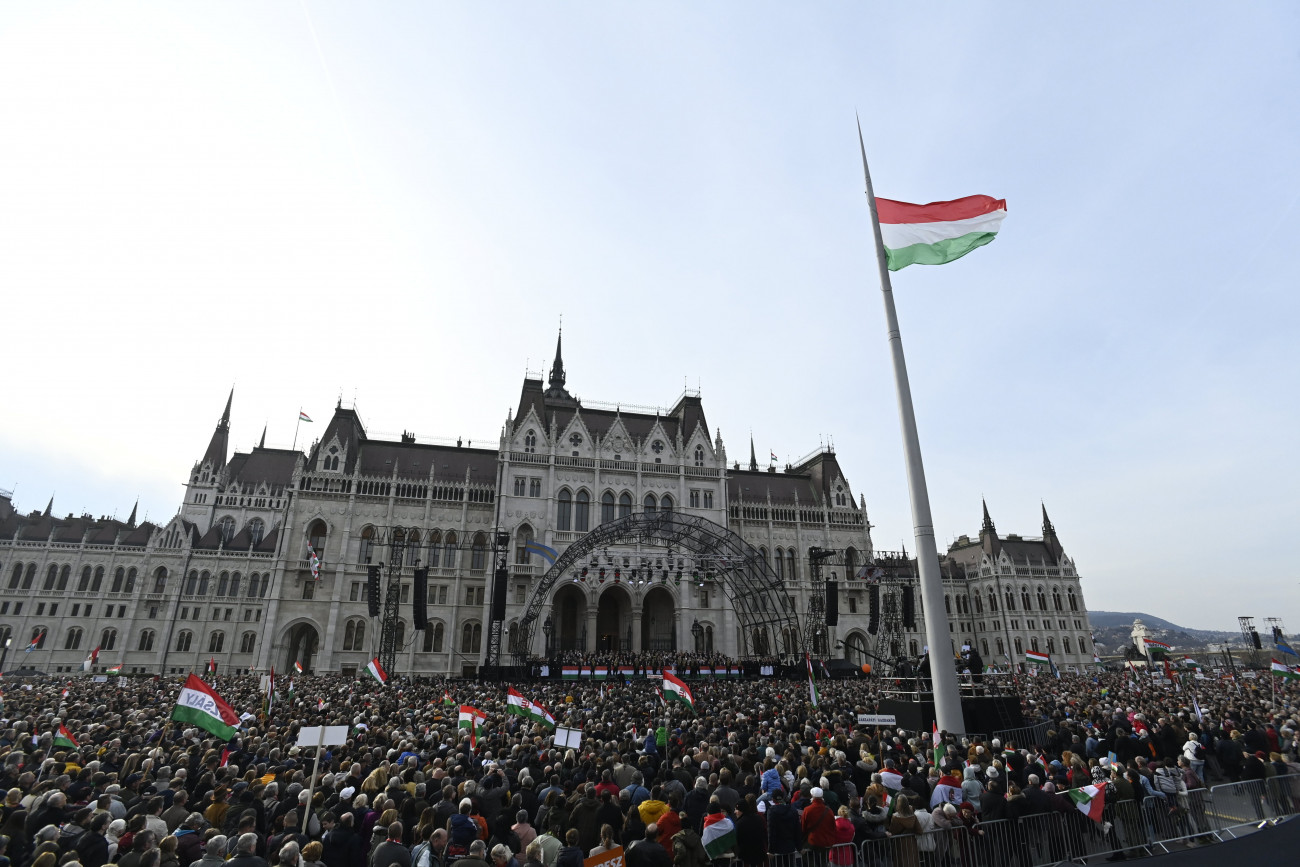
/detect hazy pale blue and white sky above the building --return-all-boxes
[0,1,1300,630]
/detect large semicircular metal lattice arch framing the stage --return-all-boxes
[515,511,803,663]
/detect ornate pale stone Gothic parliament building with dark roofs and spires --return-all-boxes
[0,343,1093,676]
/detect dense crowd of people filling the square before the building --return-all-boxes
[0,660,1300,867]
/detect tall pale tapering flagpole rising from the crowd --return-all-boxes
[858,120,966,732]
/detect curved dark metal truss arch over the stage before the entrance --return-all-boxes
[515,511,803,664]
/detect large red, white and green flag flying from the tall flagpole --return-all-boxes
[876,196,1006,270]
